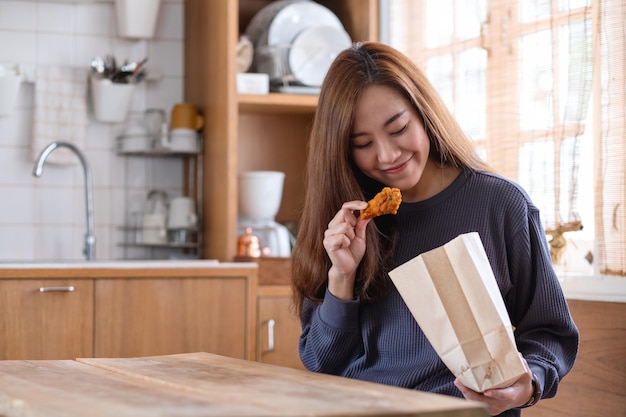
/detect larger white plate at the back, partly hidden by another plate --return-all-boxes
[267,1,343,45]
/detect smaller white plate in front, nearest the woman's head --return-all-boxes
[289,26,352,87]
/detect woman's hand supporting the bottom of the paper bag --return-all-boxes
[454,354,534,416]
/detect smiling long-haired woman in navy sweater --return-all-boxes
[292,43,578,417]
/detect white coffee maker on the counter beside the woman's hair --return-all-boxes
[238,171,291,257]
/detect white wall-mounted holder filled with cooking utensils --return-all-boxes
[91,77,135,123]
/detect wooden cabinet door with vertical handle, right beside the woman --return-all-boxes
[257,286,304,369]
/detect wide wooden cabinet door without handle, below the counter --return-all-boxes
[95,277,247,359]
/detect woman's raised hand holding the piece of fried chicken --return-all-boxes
[324,201,369,300]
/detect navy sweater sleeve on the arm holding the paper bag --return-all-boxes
[505,205,579,398]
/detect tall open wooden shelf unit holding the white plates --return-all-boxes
[184,0,379,260]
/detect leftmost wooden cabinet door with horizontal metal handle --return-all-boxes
[0,279,93,360]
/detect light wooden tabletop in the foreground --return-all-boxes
[0,353,487,417]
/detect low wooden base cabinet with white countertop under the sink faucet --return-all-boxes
[0,261,257,360]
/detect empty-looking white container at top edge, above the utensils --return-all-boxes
[115,0,161,39]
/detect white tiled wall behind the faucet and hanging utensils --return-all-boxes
[0,0,184,262]
